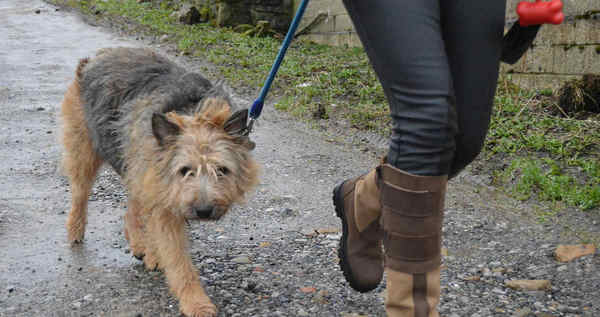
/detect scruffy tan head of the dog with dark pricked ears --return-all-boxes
[152,96,259,220]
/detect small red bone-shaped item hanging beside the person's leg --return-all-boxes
[517,0,565,26]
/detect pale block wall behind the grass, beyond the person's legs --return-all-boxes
[296,0,600,88]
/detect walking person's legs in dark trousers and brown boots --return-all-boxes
[334,0,505,316]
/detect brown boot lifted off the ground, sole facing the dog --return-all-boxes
[333,169,383,292]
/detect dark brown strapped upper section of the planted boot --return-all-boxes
[380,164,447,273]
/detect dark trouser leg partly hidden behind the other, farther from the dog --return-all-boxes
[441,0,506,178]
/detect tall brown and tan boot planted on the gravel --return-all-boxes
[380,164,448,317]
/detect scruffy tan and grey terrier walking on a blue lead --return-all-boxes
[62,48,258,317]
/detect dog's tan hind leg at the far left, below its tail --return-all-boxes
[61,80,102,243]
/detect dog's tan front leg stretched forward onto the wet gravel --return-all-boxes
[147,212,217,317]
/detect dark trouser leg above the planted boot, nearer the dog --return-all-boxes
[344,0,457,176]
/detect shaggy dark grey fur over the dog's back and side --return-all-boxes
[79,48,236,175]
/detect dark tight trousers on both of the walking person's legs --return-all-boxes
[344,0,506,177]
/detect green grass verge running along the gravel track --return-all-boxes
[56,0,600,210]
